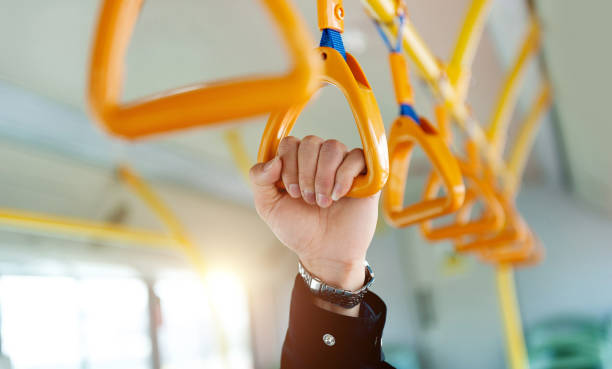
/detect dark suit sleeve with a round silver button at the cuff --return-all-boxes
[281,275,392,369]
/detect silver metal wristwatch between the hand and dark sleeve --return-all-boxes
[298,261,374,309]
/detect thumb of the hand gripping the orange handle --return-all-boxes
[249,157,283,219]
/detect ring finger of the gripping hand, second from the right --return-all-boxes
[315,140,346,208]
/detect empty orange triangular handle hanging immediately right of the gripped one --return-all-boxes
[383,116,465,227]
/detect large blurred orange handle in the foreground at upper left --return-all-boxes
[88,0,321,139]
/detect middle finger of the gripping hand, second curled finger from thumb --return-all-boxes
[298,136,323,205]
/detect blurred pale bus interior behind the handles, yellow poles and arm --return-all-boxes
[0,0,612,369]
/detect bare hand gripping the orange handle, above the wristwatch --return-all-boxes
[250,136,379,314]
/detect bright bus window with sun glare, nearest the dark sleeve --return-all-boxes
[156,272,253,369]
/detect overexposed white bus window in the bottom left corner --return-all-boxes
[0,276,151,369]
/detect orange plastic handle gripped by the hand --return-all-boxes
[257,47,389,197]
